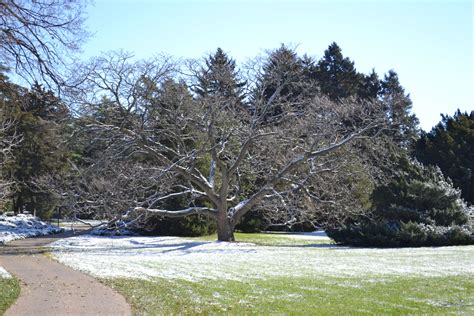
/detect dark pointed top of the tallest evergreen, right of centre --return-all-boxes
[315,42,363,100]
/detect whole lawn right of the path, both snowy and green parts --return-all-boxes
[52,234,474,315]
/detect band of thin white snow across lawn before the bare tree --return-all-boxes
[51,235,474,281]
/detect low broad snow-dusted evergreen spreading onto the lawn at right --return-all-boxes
[328,163,474,247]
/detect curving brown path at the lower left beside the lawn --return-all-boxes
[0,232,131,316]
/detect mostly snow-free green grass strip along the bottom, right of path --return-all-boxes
[104,275,474,315]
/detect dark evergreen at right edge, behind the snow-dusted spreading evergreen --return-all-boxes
[415,110,474,204]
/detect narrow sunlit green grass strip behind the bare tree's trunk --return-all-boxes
[189,233,334,246]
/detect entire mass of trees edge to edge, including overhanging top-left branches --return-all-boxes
[0,0,473,246]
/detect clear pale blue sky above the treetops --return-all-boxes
[83,0,474,130]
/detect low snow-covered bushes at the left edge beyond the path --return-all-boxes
[0,214,63,245]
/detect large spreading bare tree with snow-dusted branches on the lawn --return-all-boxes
[67,54,385,241]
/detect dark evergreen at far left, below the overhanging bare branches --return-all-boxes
[3,84,68,216]
